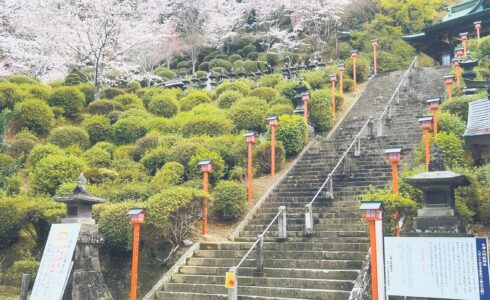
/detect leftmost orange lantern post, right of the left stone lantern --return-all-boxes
[128,208,146,300]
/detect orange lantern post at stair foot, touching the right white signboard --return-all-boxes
[360,201,383,300]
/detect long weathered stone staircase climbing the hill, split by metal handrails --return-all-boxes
[149,68,447,300]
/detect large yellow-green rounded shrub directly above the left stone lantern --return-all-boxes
[32,154,85,195]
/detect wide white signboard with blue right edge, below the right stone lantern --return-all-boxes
[385,237,490,300]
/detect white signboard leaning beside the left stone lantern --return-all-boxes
[30,224,80,300]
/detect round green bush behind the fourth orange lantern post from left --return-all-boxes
[253,141,286,175]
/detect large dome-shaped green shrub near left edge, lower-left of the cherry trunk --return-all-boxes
[12,99,54,135]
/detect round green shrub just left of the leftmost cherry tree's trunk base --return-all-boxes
[48,86,85,117]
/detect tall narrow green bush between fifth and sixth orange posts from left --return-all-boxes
[308,90,334,132]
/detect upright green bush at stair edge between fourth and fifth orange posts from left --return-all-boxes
[276,115,308,156]
